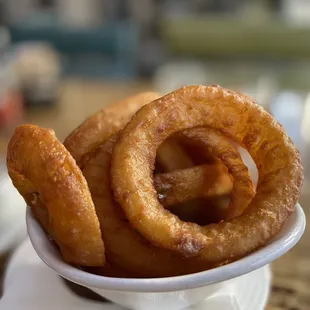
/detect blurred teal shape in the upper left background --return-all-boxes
[10,18,139,78]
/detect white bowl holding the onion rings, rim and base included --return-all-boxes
[27,204,306,310]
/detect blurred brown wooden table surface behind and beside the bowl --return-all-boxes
[0,80,310,310]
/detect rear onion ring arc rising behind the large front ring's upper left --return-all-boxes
[64,92,159,167]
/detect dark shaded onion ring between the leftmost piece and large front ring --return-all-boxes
[83,136,210,277]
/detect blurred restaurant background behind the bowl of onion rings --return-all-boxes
[0,0,310,310]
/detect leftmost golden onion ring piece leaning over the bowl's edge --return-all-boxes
[7,125,105,266]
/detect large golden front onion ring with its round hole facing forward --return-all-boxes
[111,85,303,264]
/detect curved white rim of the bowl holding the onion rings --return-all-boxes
[26,204,306,293]
